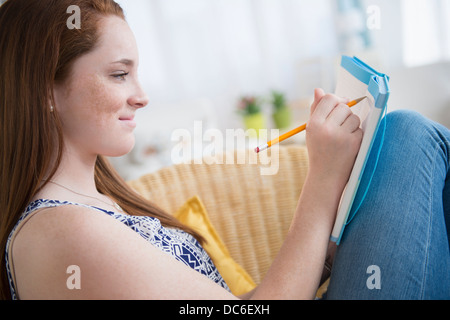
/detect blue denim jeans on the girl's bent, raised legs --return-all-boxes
[325,111,450,300]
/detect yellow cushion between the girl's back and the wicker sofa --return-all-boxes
[175,196,256,295]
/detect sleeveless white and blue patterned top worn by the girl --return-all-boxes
[5,200,230,300]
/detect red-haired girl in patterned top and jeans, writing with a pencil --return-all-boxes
[0,0,450,299]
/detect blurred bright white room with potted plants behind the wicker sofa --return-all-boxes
[86,0,450,179]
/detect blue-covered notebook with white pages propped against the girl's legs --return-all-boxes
[331,56,390,244]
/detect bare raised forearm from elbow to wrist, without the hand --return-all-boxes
[252,171,339,299]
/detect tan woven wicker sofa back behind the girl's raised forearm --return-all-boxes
[129,145,328,298]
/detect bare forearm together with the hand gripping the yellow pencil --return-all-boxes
[246,90,362,299]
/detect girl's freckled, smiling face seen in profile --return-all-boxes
[54,17,148,157]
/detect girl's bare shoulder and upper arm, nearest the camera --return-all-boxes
[13,206,236,299]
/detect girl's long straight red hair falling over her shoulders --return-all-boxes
[0,0,197,299]
